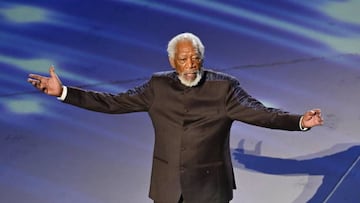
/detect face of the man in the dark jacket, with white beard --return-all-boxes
[169,40,202,86]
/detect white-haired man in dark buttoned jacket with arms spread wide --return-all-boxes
[28,33,323,203]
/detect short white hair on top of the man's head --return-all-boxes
[167,32,205,59]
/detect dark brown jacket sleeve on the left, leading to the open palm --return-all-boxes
[64,80,153,114]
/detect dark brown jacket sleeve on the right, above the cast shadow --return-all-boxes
[225,79,301,131]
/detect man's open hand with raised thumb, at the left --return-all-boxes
[27,66,63,97]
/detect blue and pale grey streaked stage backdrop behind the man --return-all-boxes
[0,0,360,203]
